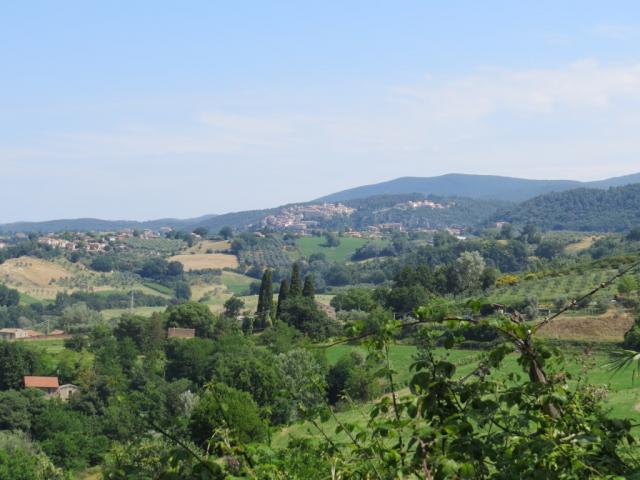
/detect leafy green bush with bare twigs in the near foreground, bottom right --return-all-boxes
[108,301,640,479]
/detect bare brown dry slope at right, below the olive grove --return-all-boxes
[539,309,634,342]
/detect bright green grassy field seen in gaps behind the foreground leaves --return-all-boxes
[272,345,640,448]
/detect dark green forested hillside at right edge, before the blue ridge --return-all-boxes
[499,184,640,232]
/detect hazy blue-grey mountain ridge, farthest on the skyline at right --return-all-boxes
[315,173,640,202]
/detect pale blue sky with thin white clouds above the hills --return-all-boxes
[0,0,640,222]
